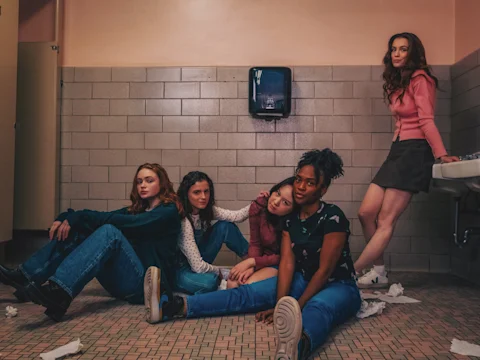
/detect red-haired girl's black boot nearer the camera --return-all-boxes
[25,281,73,322]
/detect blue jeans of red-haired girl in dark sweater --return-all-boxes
[19,225,145,304]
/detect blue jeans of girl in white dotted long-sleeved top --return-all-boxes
[176,221,248,294]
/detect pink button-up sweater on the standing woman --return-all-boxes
[390,70,447,159]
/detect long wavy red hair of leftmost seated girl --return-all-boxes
[128,163,185,218]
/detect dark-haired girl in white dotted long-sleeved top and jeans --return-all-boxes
[176,171,250,294]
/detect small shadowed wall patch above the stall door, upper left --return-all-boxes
[18,0,55,42]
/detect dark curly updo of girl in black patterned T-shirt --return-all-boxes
[296,148,343,188]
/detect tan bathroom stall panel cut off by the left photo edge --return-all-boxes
[0,0,18,242]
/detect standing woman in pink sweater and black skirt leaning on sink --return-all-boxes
[355,33,459,288]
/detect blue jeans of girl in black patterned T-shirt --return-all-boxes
[186,272,361,351]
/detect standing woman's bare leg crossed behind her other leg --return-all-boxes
[355,184,385,272]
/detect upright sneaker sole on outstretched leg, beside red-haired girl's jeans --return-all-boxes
[143,266,162,324]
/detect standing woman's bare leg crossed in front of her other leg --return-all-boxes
[355,189,412,272]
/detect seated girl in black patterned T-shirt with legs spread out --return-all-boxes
[145,149,361,359]
